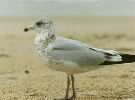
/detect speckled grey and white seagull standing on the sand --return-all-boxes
[24,17,135,100]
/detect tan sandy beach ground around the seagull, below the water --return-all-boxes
[0,17,135,100]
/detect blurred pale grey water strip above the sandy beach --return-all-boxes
[0,0,135,17]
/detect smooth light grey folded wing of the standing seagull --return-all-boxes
[49,37,121,66]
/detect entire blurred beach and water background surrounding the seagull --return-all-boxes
[0,0,135,100]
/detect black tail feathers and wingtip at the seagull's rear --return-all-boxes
[100,54,135,65]
